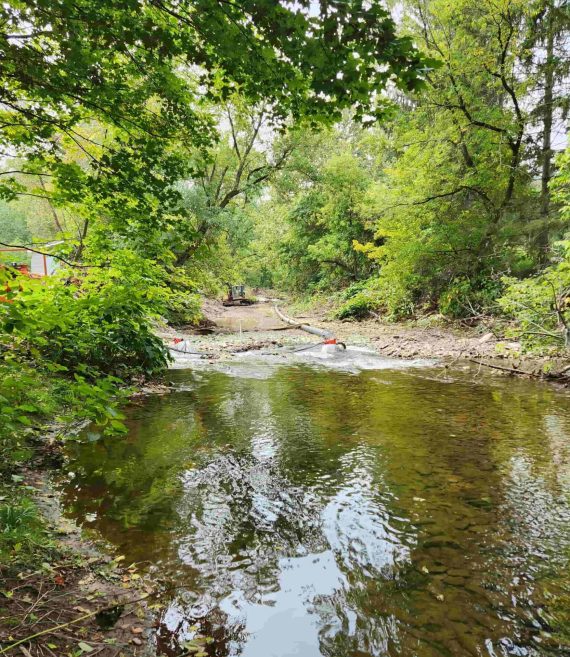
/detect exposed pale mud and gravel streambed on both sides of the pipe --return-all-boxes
[187,299,570,383]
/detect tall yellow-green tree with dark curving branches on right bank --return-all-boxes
[352,0,564,316]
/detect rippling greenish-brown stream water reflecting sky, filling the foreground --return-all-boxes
[54,363,570,657]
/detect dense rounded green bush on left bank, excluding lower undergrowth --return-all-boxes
[0,252,166,376]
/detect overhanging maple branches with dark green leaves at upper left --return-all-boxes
[0,0,426,249]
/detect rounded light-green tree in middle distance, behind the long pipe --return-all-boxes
[248,139,374,294]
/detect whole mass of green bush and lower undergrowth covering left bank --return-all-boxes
[0,250,170,470]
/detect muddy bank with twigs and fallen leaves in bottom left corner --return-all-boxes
[0,464,160,657]
